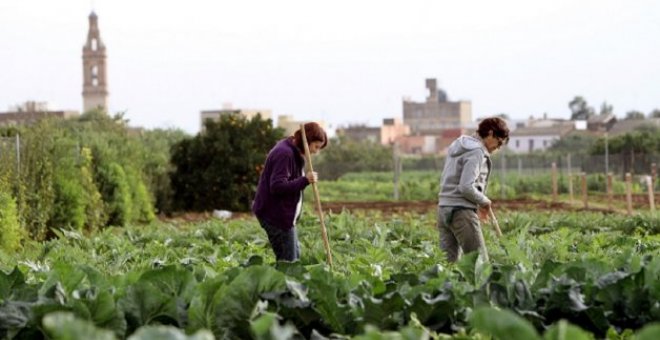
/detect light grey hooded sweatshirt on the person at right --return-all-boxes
[438,136,491,209]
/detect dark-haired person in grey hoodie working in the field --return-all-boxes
[437,117,509,262]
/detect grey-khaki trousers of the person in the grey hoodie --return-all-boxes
[437,207,484,262]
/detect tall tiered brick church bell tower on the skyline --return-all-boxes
[83,12,108,112]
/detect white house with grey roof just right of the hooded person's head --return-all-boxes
[507,124,574,153]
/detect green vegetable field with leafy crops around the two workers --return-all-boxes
[0,174,660,339]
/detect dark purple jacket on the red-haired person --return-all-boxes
[252,138,309,230]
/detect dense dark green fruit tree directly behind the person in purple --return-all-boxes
[171,115,284,211]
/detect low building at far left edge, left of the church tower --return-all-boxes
[0,101,80,126]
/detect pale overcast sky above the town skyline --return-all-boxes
[0,0,660,133]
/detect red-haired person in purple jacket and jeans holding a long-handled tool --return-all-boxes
[252,122,328,261]
